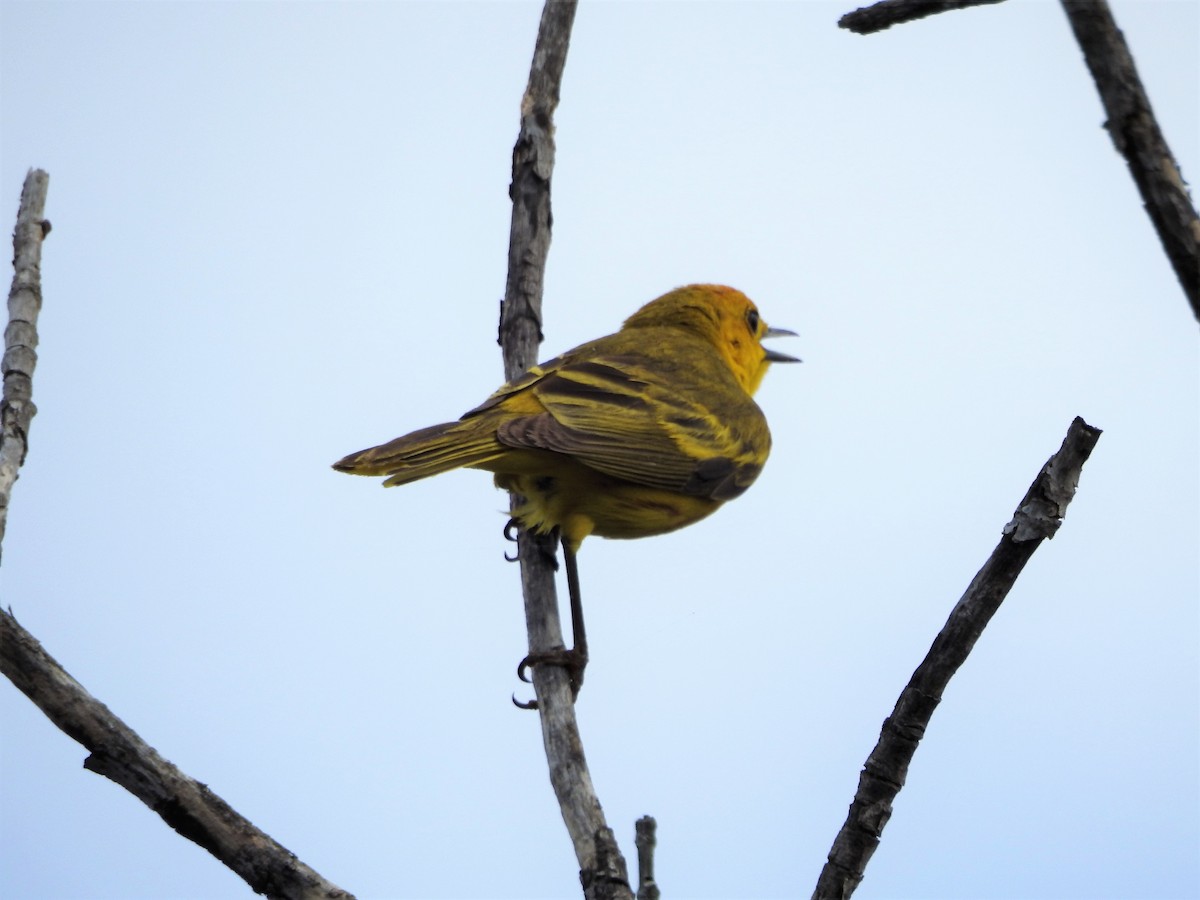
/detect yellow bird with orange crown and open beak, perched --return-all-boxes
[334,284,799,690]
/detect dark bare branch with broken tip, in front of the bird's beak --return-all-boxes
[812,418,1100,900]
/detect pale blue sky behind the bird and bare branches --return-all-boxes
[0,0,1200,900]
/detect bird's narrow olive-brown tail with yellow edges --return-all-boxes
[334,419,505,487]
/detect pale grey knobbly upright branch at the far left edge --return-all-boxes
[0,169,50,561]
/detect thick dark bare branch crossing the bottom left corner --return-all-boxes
[0,611,352,900]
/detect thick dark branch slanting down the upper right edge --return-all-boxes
[1062,0,1200,319]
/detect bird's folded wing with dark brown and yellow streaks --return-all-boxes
[487,354,770,500]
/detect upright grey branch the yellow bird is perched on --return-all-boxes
[499,0,632,900]
